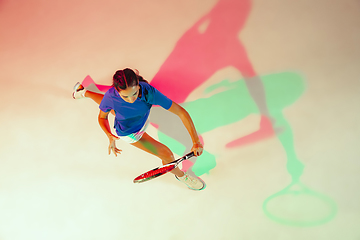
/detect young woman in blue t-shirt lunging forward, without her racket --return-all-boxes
[73,68,205,190]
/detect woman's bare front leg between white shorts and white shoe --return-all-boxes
[131,133,184,177]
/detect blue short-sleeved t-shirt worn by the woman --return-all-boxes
[99,82,172,136]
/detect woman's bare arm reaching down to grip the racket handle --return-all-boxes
[168,102,204,156]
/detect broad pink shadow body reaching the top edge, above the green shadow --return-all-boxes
[151,0,256,103]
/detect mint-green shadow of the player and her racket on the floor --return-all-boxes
[159,72,337,227]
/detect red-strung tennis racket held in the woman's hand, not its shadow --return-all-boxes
[134,152,195,183]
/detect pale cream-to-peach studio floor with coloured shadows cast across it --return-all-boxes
[0,0,360,240]
